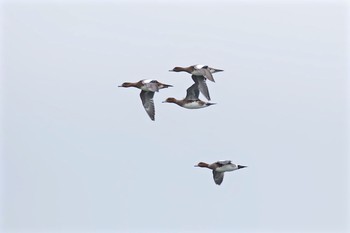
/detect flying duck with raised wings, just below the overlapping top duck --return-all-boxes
[163,83,215,109]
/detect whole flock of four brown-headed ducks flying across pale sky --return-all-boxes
[119,65,247,185]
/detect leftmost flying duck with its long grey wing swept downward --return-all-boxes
[119,79,172,121]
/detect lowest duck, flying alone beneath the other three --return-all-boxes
[195,160,247,185]
